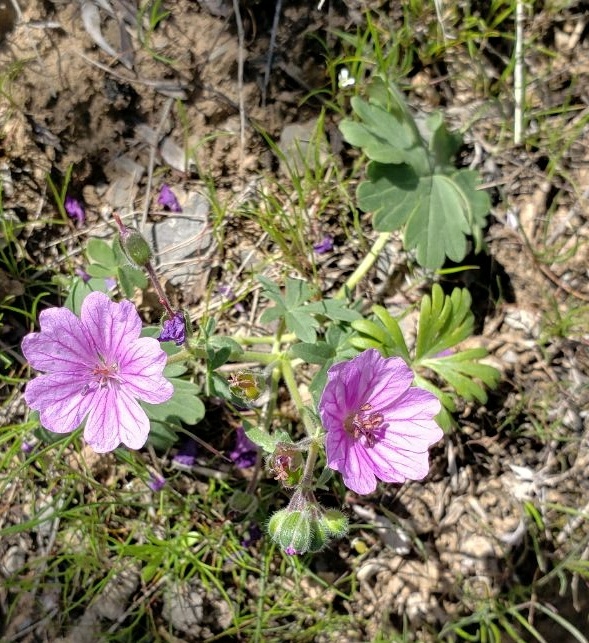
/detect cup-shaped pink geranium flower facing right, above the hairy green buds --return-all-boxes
[319,349,443,494]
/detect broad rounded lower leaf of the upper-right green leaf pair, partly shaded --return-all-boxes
[357,161,490,270]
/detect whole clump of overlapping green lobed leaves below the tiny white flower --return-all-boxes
[340,78,490,270]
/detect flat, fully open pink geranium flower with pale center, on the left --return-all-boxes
[22,292,174,453]
